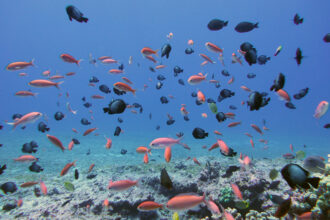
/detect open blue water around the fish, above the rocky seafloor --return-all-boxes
[0,0,330,218]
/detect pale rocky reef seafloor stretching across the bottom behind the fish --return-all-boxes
[0,157,330,220]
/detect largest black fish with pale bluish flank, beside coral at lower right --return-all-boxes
[281,163,320,189]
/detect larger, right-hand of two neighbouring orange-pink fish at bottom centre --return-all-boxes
[166,193,206,211]
